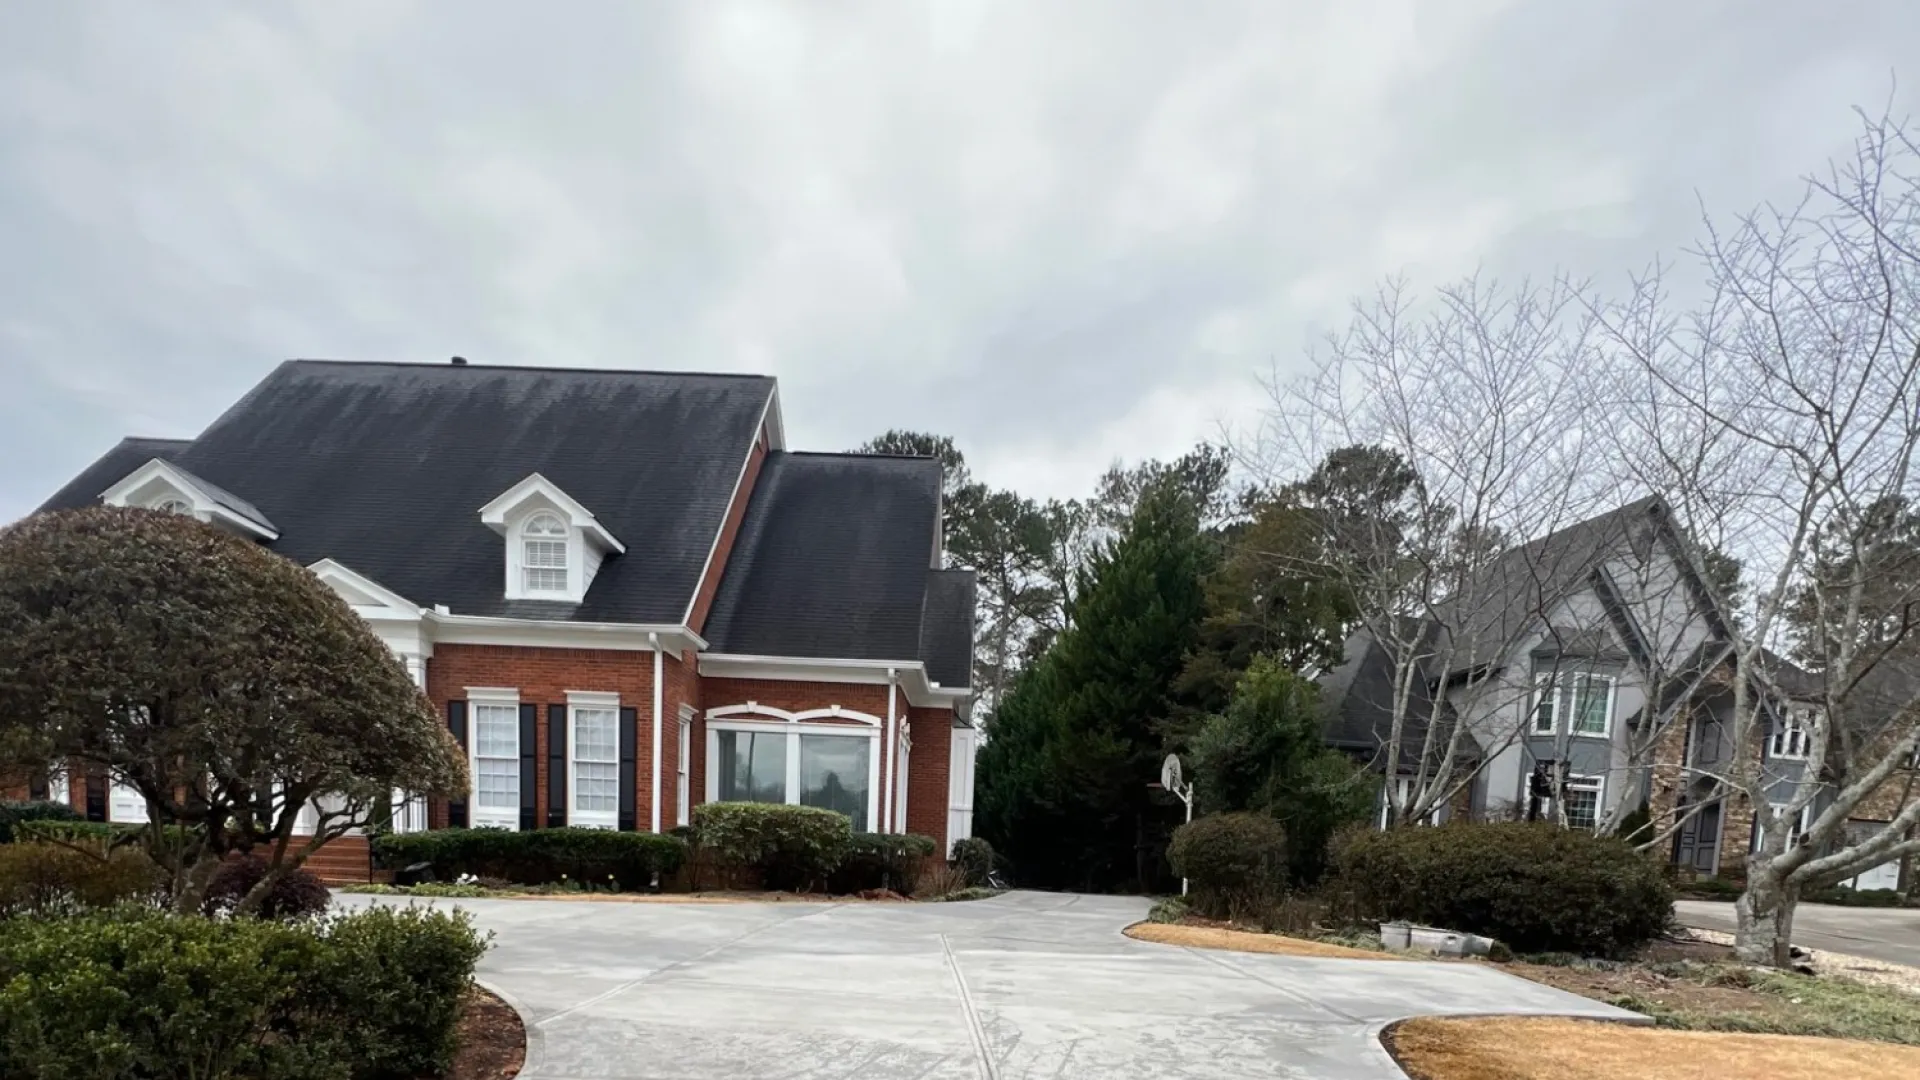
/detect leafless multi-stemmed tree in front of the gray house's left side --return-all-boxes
[1236,279,1651,822]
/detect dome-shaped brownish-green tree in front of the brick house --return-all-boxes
[0,507,467,911]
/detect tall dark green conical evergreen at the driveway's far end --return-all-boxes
[975,484,1212,888]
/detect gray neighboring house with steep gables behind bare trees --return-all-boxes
[1319,498,1916,888]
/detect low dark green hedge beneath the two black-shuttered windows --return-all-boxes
[372,828,687,892]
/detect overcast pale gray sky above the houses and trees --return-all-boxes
[0,0,1920,521]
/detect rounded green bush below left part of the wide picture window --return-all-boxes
[693,803,852,892]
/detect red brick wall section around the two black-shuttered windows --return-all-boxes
[426,646,666,828]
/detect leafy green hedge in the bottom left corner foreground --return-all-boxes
[0,907,486,1080]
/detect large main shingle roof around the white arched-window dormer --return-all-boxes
[37,361,774,623]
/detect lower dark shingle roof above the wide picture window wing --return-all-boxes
[707,452,956,668]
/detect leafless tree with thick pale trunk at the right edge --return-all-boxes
[1596,102,1920,963]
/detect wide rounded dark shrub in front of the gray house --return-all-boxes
[1336,822,1672,957]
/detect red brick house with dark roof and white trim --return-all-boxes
[28,359,975,868]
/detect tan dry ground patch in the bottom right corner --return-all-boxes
[1382,1017,1920,1080]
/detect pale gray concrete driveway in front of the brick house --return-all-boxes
[338,894,1632,1080]
